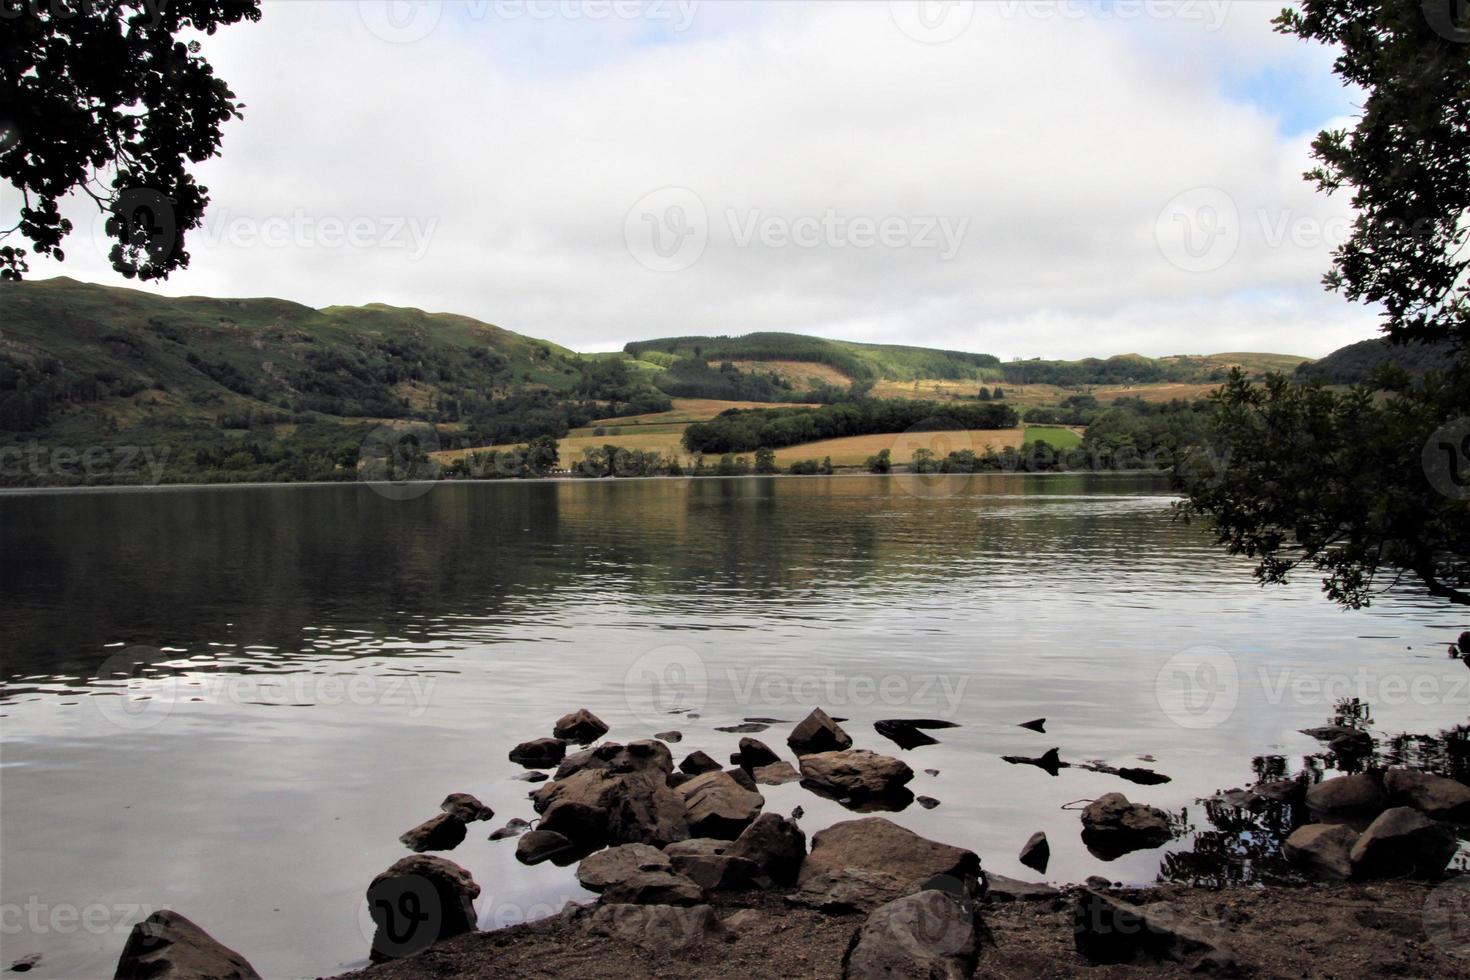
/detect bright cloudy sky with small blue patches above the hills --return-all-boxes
[6,0,1376,359]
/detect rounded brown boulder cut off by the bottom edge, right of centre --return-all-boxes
[842,890,982,980]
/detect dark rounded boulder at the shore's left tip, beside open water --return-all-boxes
[368,852,479,962]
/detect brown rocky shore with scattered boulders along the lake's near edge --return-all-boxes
[103,708,1470,980]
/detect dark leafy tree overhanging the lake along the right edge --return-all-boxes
[1177,0,1470,608]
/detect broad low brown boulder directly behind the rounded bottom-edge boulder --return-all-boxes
[797,817,980,901]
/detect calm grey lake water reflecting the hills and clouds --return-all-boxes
[0,476,1470,977]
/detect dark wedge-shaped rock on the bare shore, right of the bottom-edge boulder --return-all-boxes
[1073,889,1238,973]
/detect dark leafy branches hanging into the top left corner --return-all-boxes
[0,0,260,279]
